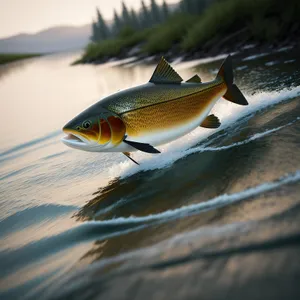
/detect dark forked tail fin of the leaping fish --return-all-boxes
[217,55,248,105]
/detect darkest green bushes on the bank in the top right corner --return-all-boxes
[181,0,300,50]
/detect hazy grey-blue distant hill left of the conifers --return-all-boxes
[0,24,91,53]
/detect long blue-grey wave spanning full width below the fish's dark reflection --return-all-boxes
[0,170,300,275]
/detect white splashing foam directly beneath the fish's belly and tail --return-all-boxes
[109,86,300,178]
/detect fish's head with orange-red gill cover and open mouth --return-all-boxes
[62,104,126,152]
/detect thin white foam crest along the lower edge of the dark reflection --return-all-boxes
[89,170,300,225]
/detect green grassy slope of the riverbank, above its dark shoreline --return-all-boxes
[77,0,300,62]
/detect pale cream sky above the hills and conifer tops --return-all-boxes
[0,0,179,37]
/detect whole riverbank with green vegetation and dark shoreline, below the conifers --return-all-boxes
[74,0,300,64]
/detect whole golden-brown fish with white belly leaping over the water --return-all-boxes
[62,55,248,164]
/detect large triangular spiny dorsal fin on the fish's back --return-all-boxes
[149,57,183,83]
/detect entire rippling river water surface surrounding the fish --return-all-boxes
[0,49,300,299]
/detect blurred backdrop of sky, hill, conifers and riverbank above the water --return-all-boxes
[0,0,300,63]
